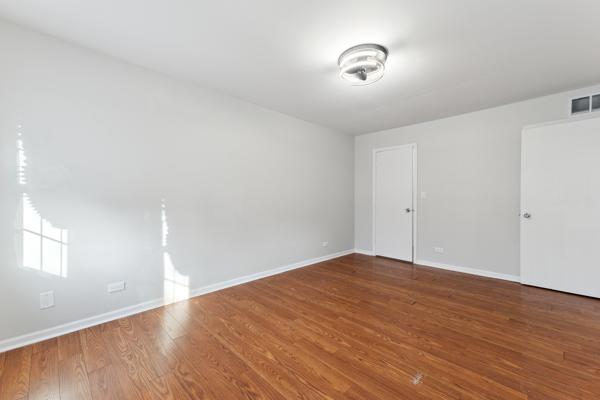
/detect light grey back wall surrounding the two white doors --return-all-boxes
[355,87,600,276]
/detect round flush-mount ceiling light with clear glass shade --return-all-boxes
[338,43,388,85]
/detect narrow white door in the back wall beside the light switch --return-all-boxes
[373,145,415,262]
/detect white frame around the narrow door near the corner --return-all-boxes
[371,143,419,263]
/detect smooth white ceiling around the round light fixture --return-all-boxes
[0,0,600,134]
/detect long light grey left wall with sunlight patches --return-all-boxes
[0,23,354,346]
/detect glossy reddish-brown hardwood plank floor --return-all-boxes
[0,254,600,400]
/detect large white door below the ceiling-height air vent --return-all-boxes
[521,118,600,297]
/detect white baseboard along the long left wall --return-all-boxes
[0,249,355,353]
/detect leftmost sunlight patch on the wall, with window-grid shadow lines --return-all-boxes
[17,126,68,278]
